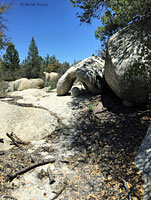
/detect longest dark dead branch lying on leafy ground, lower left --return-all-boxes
[8,159,55,181]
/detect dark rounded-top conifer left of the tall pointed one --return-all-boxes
[1,42,20,80]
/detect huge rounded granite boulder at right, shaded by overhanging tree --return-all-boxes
[105,19,151,103]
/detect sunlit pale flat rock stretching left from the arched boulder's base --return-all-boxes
[11,89,85,125]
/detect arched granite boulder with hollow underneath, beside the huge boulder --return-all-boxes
[57,56,104,95]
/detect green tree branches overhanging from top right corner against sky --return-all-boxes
[70,0,151,45]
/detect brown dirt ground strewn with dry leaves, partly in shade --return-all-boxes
[0,89,151,200]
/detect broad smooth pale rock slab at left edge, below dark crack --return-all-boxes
[0,101,57,150]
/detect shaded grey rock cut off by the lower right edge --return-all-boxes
[135,125,151,200]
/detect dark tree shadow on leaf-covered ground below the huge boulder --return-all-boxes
[68,90,151,199]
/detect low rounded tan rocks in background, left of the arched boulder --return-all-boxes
[7,78,44,92]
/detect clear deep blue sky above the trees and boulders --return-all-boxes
[4,0,101,64]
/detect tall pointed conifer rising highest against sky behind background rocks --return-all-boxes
[23,37,42,78]
